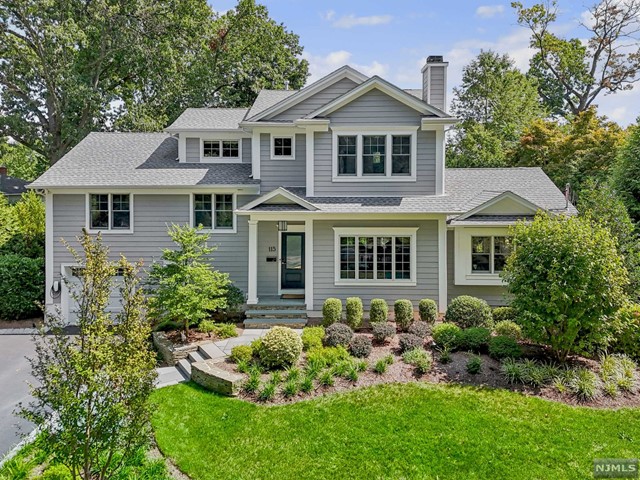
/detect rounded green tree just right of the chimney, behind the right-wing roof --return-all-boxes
[448,51,543,167]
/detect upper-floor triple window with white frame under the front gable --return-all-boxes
[333,131,416,181]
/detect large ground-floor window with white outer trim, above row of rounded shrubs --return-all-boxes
[334,228,417,284]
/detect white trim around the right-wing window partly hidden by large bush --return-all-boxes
[454,227,509,287]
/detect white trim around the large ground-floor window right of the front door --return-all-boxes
[333,227,418,287]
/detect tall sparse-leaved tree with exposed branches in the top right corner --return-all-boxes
[511,0,640,117]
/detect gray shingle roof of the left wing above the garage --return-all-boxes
[29,133,260,188]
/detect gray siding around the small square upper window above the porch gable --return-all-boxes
[260,133,307,194]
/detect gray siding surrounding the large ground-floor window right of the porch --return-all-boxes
[313,220,438,310]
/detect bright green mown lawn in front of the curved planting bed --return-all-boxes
[153,383,640,480]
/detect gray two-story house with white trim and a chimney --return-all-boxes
[31,57,574,324]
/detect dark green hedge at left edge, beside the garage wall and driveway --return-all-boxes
[0,255,44,320]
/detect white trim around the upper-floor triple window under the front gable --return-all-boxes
[331,126,418,182]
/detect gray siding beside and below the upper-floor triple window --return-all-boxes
[314,130,436,196]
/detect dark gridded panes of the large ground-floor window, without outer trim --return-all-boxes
[338,235,413,282]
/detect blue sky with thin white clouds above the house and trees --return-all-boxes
[210,0,640,125]
